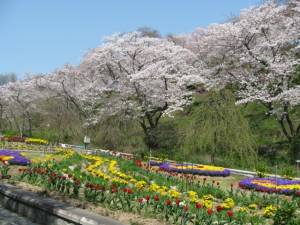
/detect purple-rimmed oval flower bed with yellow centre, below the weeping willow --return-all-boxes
[159,162,230,177]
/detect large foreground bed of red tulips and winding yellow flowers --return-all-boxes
[10,149,297,225]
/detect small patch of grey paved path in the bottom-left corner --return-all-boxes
[0,206,38,225]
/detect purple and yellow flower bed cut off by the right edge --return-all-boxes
[239,177,300,195]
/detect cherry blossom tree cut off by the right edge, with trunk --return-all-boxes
[187,0,300,156]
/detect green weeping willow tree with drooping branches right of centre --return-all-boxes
[183,89,256,166]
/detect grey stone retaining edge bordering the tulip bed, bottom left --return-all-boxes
[0,183,121,225]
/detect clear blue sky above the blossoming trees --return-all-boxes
[0,0,260,78]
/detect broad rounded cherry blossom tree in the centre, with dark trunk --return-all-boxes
[78,32,203,147]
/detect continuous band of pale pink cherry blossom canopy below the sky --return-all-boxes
[0,0,300,130]
